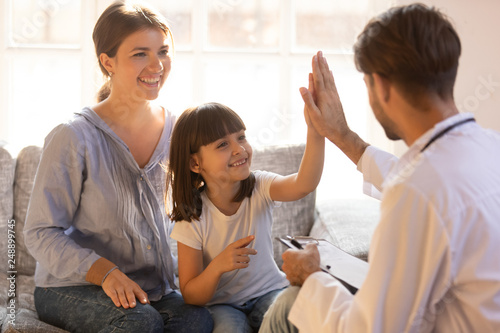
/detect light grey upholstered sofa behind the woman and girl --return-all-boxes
[0,145,378,333]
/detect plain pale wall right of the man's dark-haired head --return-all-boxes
[396,0,500,131]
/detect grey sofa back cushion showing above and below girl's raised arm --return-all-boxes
[251,144,316,267]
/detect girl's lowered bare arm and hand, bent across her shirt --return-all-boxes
[177,235,257,306]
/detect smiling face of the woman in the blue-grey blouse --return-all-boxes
[106,28,172,100]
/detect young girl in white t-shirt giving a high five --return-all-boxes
[167,103,324,332]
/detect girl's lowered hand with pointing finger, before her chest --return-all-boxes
[213,235,257,274]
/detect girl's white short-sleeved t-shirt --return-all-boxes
[171,171,288,305]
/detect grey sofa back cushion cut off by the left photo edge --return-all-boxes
[0,147,15,272]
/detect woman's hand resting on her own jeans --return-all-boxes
[102,269,149,309]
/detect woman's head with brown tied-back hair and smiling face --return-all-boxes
[92,1,173,101]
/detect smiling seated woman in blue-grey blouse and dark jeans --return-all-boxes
[25,2,212,332]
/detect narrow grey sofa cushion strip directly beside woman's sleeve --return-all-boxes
[14,146,42,275]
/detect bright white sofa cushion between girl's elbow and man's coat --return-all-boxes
[310,197,380,260]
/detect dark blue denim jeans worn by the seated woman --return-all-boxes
[35,286,213,333]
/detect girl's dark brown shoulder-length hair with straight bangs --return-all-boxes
[167,103,255,222]
